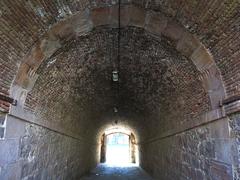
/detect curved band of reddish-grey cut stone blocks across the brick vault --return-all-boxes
[11,5,225,109]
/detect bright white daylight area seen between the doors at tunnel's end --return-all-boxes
[106,133,130,166]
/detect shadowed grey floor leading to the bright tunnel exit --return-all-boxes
[80,164,153,180]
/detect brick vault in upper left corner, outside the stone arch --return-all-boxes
[0,0,116,111]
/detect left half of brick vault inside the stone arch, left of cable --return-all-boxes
[26,27,117,134]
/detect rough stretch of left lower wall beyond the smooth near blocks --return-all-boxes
[19,125,94,179]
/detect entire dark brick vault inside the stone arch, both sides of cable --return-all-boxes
[23,27,210,136]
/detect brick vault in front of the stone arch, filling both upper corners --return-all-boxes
[1,0,240,109]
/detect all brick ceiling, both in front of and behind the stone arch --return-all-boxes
[0,0,240,137]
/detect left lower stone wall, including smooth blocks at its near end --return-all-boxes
[0,115,97,180]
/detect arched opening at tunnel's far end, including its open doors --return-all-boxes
[100,129,139,165]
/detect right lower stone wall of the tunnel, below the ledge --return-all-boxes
[141,118,237,180]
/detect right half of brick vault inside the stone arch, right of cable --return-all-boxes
[120,29,210,130]
